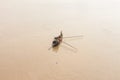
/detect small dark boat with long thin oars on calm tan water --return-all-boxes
[48,31,81,50]
